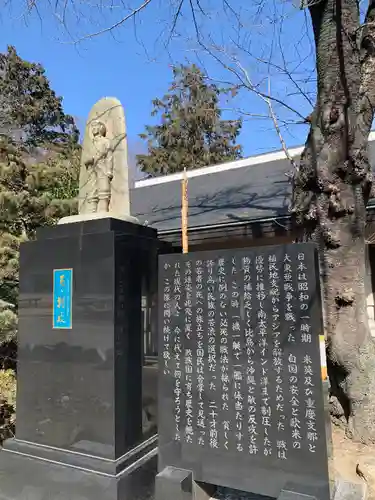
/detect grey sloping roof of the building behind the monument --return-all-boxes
[130,142,375,231]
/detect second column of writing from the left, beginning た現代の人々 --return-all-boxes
[172,262,182,441]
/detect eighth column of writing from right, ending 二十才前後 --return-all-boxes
[206,260,219,448]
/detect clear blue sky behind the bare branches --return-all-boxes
[0,0,311,165]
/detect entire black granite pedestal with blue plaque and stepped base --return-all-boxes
[0,218,166,500]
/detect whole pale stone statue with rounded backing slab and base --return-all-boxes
[59,97,138,224]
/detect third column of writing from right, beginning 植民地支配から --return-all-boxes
[268,254,288,460]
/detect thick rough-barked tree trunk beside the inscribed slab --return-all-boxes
[292,0,375,443]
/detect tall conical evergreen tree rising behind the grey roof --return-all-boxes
[137,65,242,175]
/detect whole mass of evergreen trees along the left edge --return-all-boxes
[0,47,80,350]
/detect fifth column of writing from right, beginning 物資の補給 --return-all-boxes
[242,257,259,455]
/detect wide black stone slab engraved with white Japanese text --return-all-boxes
[159,244,331,500]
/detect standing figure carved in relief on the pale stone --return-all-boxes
[85,120,113,213]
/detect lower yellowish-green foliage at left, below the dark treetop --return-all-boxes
[0,141,79,343]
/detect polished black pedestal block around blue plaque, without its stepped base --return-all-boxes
[17,219,158,458]
